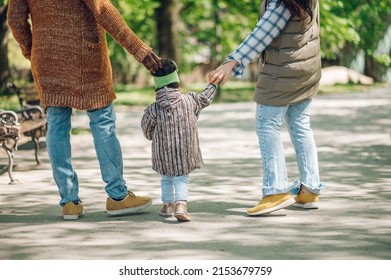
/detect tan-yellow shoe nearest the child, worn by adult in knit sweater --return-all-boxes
[106,191,152,216]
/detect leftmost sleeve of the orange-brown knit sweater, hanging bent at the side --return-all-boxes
[7,0,32,59]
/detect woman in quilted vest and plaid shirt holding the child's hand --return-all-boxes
[209,0,325,216]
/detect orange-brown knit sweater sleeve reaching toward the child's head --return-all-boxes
[83,0,152,62]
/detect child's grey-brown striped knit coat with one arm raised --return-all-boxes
[141,84,216,176]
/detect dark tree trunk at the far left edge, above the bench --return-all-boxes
[0,5,11,93]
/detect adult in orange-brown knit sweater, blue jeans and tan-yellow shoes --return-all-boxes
[7,0,161,219]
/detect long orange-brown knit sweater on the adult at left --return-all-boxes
[7,0,152,110]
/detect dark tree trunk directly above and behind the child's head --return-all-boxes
[156,0,179,64]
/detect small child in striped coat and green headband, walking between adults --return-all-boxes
[141,59,216,222]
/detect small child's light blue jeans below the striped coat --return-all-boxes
[161,175,189,203]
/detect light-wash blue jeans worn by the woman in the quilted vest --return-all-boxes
[256,99,325,197]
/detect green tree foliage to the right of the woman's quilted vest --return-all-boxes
[320,0,391,63]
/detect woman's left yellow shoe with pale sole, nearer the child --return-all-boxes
[247,193,295,216]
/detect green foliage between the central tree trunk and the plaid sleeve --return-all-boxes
[181,0,259,67]
